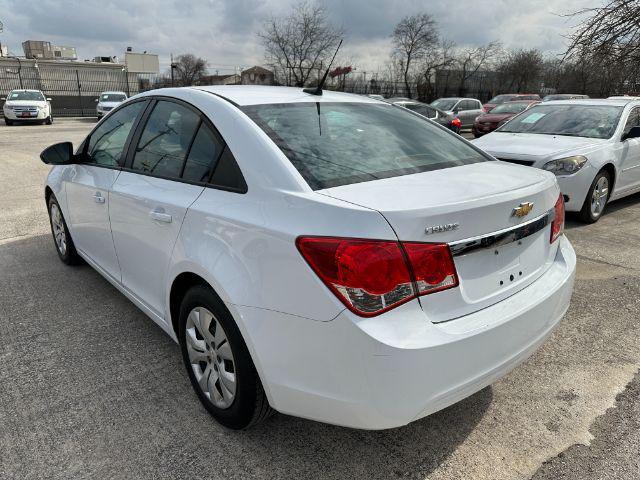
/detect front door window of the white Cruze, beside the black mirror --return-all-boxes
[84,102,145,167]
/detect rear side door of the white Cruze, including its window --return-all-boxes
[111,98,222,318]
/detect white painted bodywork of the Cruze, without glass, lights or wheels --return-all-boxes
[47,87,575,429]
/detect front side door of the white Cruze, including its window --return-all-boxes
[65,101,146,281]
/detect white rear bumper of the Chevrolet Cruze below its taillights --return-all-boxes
[229,236,576,429]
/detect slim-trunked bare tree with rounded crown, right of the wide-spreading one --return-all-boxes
[392,13,438,98]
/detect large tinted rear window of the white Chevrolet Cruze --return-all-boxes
[242,102,489,190]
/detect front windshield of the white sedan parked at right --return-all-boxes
[498,105,622,138]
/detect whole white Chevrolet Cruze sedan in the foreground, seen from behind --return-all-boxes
[41,86,576,429]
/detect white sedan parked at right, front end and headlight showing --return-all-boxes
[473,97,640,223]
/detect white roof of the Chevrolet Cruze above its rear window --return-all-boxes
[190,85,386,105]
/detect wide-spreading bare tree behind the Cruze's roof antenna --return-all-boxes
[258,1,343,87]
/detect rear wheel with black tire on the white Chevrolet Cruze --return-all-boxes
[178,285,274,430]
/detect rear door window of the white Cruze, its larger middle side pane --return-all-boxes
[131,100,200,178]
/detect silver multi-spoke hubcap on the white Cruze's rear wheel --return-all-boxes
[186,307,236,409]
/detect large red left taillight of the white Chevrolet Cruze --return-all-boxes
[296,237,458,317]
